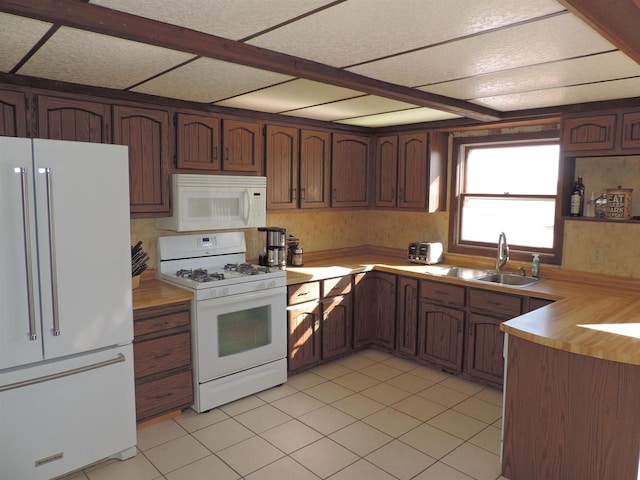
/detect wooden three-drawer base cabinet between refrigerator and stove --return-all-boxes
[133,302,193,423]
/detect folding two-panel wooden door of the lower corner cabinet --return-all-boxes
[353,272,396,350]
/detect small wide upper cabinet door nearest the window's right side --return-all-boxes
[562,113,617,152]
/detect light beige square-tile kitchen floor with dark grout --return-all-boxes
[58,349,506,480]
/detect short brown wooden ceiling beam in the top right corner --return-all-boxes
[559,0,640,64]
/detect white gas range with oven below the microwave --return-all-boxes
[158,232,287,412]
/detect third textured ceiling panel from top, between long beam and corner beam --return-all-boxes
[349,14,614,86]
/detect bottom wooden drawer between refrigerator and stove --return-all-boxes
[136,370,193,422]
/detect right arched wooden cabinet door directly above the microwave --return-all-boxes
[222,119,262,175]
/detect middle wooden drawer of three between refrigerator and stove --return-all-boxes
[133,332,191,378]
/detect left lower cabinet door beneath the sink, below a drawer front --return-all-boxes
[418,302,465,371]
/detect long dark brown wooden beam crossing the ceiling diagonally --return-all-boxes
[0,0,502,122]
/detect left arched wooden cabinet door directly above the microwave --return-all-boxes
[176,113,222,171]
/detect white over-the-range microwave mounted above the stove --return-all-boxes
[156,174,267,232]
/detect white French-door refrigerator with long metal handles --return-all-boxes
[0,137,136,480]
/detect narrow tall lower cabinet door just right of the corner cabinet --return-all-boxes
[396,277,418,356]
